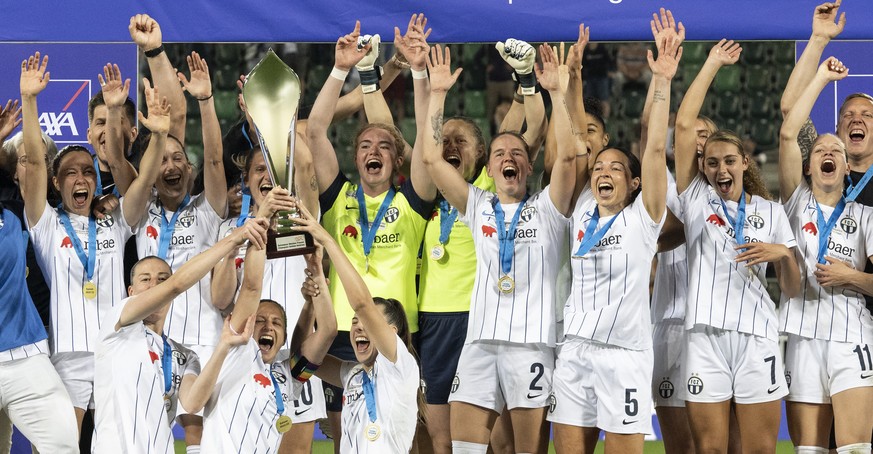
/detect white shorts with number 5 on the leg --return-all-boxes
[546,338,654,434]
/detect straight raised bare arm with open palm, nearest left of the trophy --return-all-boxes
[178,52,227,217]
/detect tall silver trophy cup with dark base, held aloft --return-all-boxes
[242,49,315,259]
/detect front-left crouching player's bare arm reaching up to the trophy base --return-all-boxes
[115,219,268,331]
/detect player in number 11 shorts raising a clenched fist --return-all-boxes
[779,57,873,454]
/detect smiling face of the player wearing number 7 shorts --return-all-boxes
[703,140,749,201]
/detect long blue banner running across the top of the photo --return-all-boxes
[0,0,873,42]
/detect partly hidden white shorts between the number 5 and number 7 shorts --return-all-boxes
[652,320,685,407]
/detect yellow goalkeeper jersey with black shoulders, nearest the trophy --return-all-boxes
[319,173,433,332]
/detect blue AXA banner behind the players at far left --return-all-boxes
[0,43,137,148]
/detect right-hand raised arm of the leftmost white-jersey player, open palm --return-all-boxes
[122,78,171,225]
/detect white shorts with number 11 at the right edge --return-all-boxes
[785,334,873,404]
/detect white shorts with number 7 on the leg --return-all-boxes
[685,325,788,404]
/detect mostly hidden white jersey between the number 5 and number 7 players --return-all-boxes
[651,172,688,323]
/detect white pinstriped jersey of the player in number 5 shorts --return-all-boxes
[564,189,666,350]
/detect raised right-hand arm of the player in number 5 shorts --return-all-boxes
[642,36,682,222]
